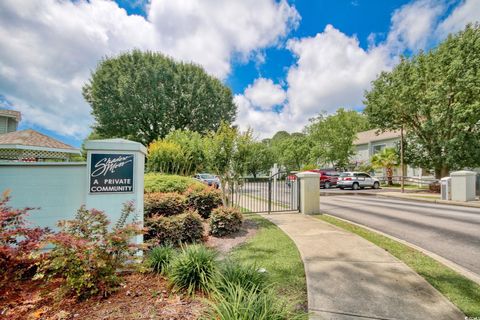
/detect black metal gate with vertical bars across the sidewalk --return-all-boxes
[231,172,300,213]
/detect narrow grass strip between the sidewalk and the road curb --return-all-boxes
[317,215,480,317]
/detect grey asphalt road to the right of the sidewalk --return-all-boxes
[320,195,480,275]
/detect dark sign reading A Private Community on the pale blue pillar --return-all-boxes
[89,153,134,193]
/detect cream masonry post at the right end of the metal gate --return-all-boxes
[297,172,320,214]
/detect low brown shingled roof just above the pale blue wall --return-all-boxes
[0,129,80,154]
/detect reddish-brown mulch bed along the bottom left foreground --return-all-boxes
[0,273,205,320]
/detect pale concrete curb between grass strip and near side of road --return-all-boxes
[322,213,480,285]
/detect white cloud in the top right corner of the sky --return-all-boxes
[437,0,480,38]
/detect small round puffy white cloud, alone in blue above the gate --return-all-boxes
[245,78,287,110]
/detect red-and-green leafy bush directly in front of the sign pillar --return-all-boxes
[35,203,143,298]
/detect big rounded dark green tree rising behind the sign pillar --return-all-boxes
[83,50,236,145]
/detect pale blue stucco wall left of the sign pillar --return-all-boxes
[0,162,87,228]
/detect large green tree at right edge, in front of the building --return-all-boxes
[365,24,480,178]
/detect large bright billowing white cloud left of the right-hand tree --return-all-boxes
[287,25,392,119]
